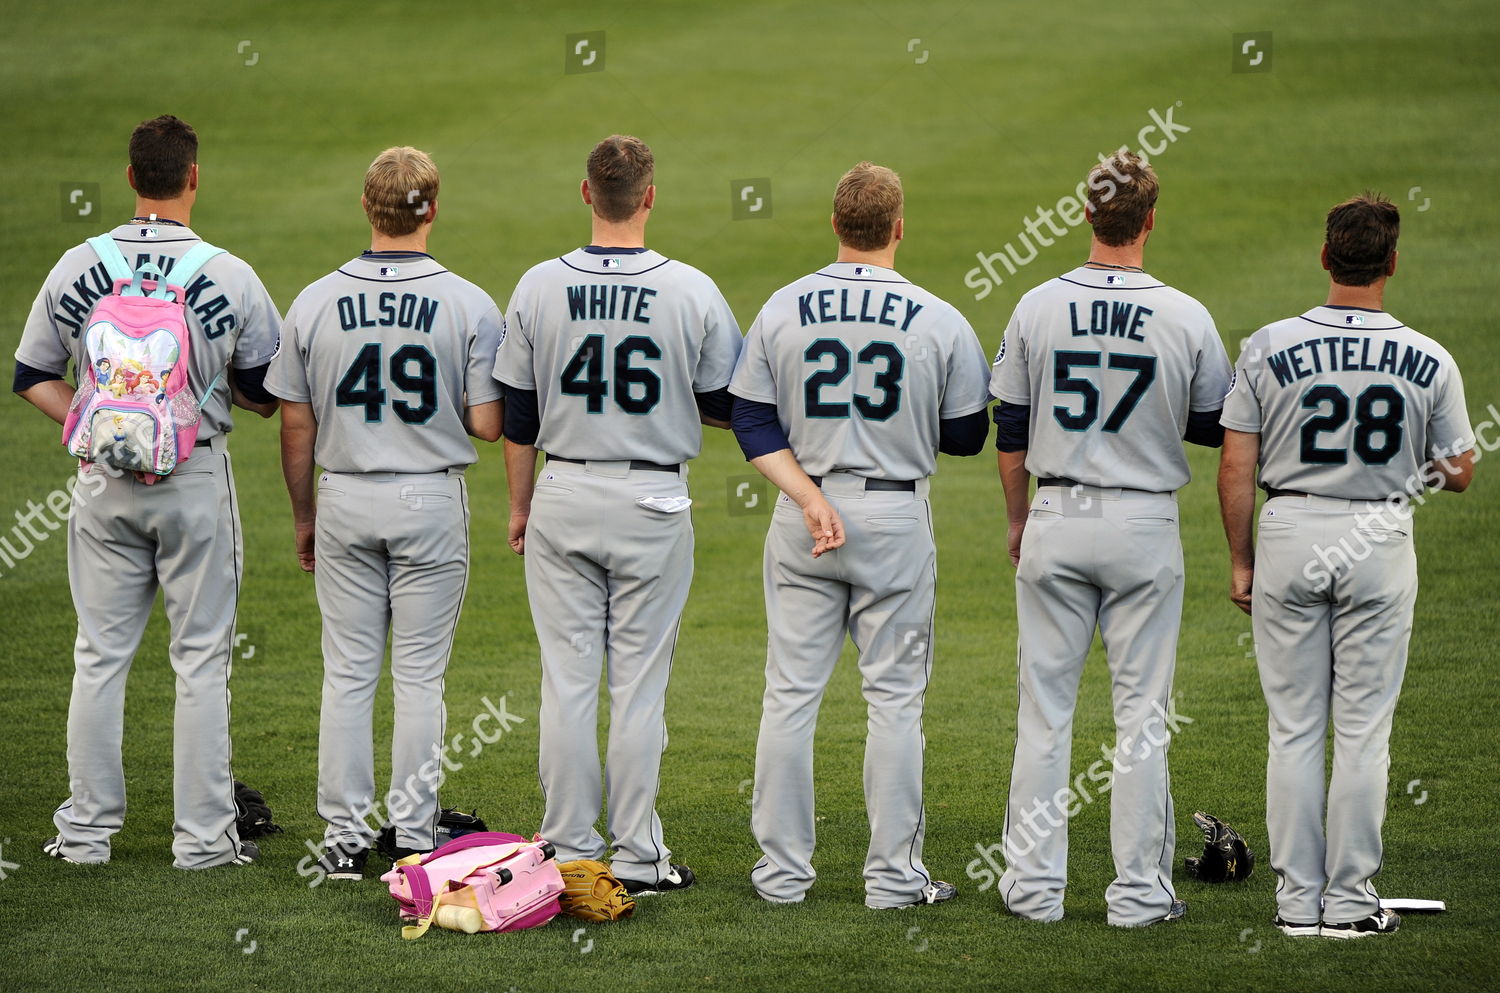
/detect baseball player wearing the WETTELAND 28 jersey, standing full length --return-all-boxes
[1220,195,1475,938]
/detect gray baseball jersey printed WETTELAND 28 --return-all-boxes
[1221,308,1475,500]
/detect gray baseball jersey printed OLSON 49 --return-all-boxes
[266,252,504,473]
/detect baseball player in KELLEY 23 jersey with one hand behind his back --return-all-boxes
[729,162,990,909]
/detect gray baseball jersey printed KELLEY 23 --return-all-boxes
[729,263,990,480]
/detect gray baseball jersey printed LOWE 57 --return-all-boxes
[990,266,1230,492]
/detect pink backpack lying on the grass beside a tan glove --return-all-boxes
[381,831,563,941]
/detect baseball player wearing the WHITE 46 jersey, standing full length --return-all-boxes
[495,135,741,896]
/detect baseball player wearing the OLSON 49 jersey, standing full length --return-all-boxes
[267,147,504,879]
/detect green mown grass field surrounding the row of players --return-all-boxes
[0,0,1500,993]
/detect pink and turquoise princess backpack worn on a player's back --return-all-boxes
[63,234,224,483]
